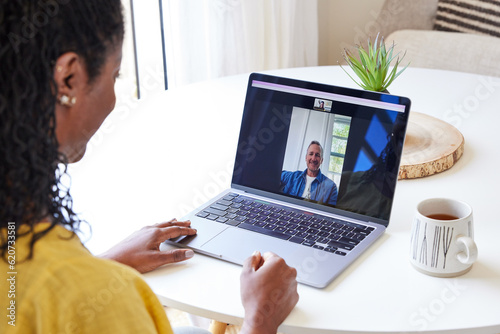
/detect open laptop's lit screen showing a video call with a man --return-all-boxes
[232,73,410,226]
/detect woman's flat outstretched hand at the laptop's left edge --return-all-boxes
[100,219,196,273]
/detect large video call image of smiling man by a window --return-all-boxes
[281,107,351,205]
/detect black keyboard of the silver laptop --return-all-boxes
[196,193,374,256]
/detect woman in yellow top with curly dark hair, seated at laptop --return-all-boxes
[0,0,298,333]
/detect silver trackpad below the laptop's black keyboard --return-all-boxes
[203,227,299,264]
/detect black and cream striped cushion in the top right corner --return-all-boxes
[434,0,500,37]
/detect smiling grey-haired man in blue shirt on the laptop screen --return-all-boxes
[281,140,338,205]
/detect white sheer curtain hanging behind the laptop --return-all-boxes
[162,0,318,87]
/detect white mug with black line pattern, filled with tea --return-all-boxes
[410,198,477,277]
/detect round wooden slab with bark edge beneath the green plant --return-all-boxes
[398,111,464,179]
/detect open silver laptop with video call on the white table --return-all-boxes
[166,73,410,288]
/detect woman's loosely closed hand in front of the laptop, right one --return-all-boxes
[240,252,299,334]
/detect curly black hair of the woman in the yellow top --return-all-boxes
[0,0,124,260]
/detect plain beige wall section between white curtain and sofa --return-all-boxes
[318,0,384,65]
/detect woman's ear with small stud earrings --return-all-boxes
[54,52,87,107]
